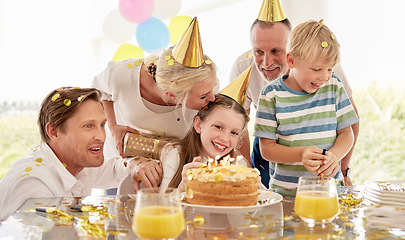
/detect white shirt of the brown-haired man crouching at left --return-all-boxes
[0,143,130,220]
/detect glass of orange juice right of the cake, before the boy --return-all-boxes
[294,176,339,226]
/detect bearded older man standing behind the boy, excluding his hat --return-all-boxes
[229,0,359,187]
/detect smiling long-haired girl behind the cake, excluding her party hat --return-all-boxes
[160,94,249,191]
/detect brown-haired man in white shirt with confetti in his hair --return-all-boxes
[0,88,139,220]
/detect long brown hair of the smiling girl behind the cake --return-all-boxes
[169,93,249,187]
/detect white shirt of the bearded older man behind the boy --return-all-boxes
[229,50,352,110]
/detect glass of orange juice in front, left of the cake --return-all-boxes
[132,188,185,240]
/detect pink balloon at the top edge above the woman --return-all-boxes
[118,0,155,23]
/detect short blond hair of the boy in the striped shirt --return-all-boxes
[289,20,340,66]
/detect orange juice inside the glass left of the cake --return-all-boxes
[132,206,185,238]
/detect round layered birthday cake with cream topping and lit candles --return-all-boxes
[186,160,259,206]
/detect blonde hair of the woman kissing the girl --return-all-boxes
[145,47,216,106]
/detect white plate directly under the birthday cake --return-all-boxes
[181,190,283,213]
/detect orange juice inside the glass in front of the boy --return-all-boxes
[294,191,339,220]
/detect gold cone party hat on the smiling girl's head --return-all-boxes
[219,66,252,106]
